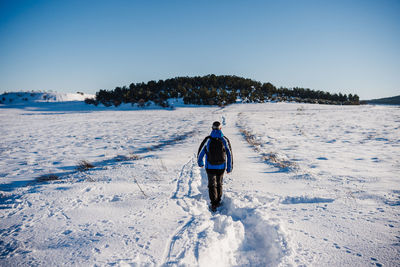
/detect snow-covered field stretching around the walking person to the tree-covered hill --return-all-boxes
[0,103,400,266]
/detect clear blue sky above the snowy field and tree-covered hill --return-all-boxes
[0,0,400,99]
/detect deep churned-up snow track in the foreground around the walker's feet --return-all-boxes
[163,156,286,266]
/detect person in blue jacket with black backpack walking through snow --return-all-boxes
[197,121,233,212]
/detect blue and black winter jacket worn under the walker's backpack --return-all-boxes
[197,130,233,172]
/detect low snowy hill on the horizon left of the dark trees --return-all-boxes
[0,92,95,105]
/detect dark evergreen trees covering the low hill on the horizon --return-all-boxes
[85,74,359,107]
